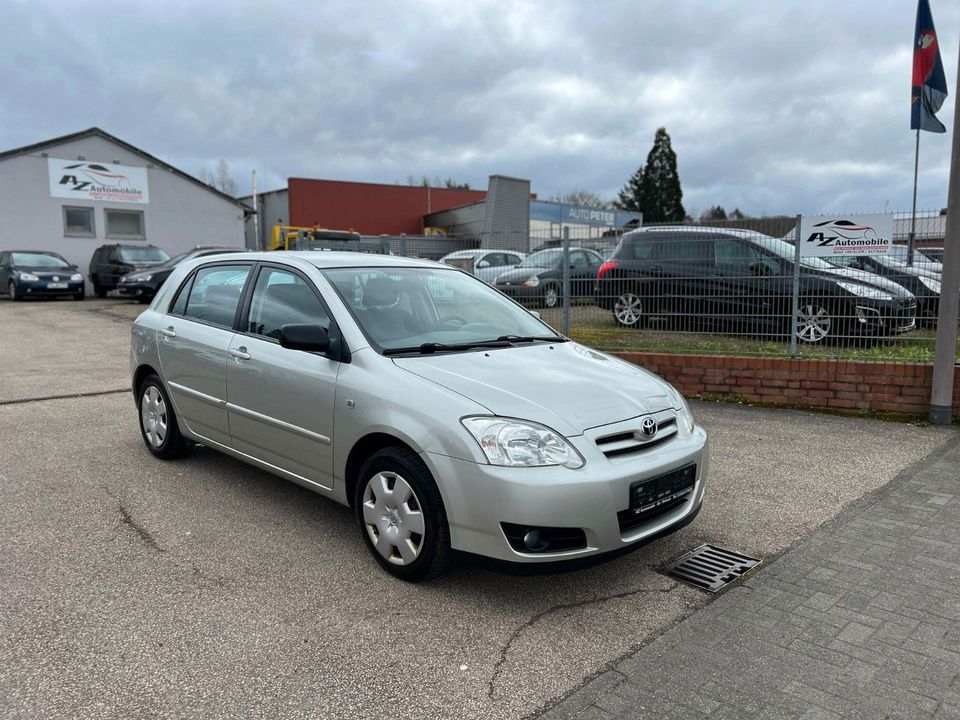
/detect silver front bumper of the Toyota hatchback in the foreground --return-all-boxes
[422,421,708,563]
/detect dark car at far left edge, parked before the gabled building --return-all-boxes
[0,250,84,300]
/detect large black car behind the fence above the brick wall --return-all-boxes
[594,227,917,343]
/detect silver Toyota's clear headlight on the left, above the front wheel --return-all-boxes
[460,417,584,469]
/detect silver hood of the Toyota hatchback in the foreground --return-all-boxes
[393,342,672,437]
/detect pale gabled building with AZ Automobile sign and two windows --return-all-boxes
[0,128,251,284]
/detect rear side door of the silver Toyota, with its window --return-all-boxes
[157,263,253,446]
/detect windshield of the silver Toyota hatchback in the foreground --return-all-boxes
[323,267,563,351]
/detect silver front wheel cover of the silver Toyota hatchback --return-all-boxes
[362,470,426,565]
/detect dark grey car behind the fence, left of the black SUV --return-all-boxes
[494,248,603,308]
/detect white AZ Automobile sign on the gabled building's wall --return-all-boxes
[47,158,150,204]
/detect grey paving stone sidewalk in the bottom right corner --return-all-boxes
[541,440,960,720]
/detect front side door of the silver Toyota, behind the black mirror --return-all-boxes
[227,265,340,488]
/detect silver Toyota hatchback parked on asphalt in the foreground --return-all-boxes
[131,252,707,580]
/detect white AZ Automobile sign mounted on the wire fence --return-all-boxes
[800,213,893,257]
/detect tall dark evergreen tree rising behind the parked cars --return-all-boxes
[619,128,686,223]
